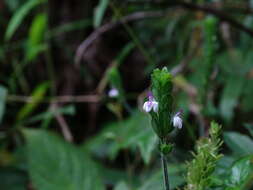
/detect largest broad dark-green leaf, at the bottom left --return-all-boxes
[24,130,104,190]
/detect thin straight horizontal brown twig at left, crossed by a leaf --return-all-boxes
[7,95,101,103]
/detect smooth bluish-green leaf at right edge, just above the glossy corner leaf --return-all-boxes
[224,132,253,155]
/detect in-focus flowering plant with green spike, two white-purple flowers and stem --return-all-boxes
[143,68,182,190]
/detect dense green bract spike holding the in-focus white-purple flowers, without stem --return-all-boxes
[150,68,173,140]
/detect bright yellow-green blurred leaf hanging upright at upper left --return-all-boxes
[26,13,47,61]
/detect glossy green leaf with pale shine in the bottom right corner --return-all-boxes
[227,156,253,189]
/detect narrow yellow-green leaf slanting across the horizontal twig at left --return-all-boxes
[17,82,49,121]
